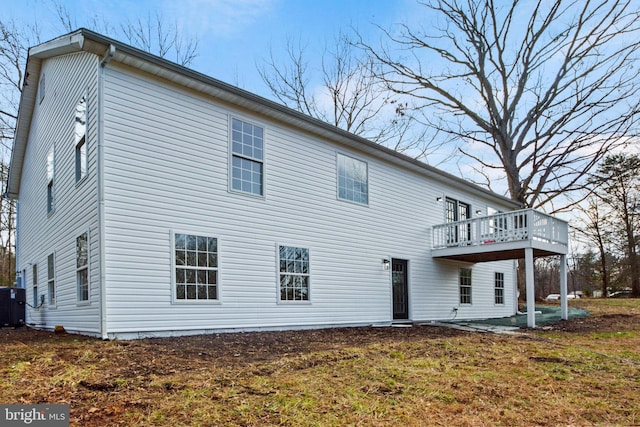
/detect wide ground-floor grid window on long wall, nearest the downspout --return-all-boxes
[174,233,218,301]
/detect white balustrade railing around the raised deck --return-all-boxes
[433,209,568,249]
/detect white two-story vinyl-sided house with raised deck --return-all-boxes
[7,29,567,338]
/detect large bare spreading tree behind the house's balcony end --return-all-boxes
[360,0,640,211]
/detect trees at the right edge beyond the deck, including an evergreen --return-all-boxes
[536,153,640,298]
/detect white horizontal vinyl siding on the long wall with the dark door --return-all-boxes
[97,63,515,337]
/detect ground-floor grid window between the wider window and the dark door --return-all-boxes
[278,246,310,301]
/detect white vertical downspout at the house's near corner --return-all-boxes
[96,44,116,340]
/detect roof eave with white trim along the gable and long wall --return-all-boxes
[7,29,522,208]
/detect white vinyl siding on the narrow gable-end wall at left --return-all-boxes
[16,53,100,335]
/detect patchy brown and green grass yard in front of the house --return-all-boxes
[0,299,640,426]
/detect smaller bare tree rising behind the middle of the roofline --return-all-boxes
[258,34,448,158]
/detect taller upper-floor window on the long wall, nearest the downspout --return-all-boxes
[231,119,264,196]
